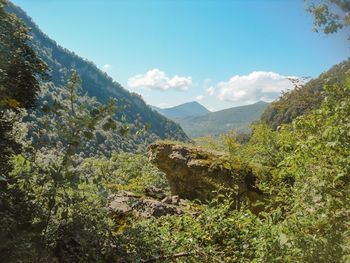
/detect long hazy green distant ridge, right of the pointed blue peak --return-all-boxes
[173,101,269,138]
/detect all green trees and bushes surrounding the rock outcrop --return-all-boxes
[0,0,350,263]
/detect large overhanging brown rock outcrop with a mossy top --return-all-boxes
[149,142,261,207]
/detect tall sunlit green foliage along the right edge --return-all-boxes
[270,77,350,262]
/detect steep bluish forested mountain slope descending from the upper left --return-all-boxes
[7,3,188,151]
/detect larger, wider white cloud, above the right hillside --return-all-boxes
[217,71,295,103]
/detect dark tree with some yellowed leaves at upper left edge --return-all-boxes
[0,0,47,175]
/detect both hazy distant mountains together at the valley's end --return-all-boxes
[153,101,269,138]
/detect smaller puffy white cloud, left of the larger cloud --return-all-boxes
[128,69,192,91]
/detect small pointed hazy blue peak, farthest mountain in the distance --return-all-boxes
[152,101,210,119]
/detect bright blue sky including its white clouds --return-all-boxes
[13,0,350,111]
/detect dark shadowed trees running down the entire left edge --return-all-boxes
[0,0,47,262]
